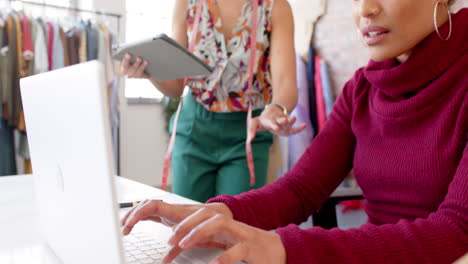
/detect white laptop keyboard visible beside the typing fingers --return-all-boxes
[123,233,169,264]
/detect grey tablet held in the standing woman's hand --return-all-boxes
[113,34,213,81]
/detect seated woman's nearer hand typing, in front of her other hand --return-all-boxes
[163,207,286,264]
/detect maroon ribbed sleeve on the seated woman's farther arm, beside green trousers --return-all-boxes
[208,68,361,230]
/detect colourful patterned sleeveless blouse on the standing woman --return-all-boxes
[187,0,274,112]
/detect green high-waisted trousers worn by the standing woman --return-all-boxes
[169,93,273,202]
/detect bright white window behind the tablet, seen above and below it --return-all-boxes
[125,0,175,99]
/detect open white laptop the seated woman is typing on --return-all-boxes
[21,61,236,264]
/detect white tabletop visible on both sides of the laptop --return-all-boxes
[0,175,194,264]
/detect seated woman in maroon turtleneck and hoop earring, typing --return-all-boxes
[122,0,468,264]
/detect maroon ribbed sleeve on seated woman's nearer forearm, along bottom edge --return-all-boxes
[276,142,468,264]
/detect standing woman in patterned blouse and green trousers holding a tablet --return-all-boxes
[122,0,305,202]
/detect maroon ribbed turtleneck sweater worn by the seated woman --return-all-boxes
[209,8,468,264]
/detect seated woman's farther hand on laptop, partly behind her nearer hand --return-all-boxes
[121,200,232,235]
